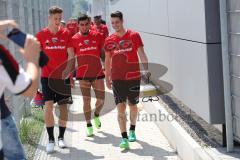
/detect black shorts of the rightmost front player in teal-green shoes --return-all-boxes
[112,80,140,105]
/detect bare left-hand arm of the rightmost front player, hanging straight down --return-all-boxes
[105,51,112,89]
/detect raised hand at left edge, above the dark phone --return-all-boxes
[0,20,18,40]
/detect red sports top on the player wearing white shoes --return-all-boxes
[36,28,71,79]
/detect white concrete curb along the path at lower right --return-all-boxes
[142,102,218,160]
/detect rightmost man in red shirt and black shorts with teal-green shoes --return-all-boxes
[104,11,150,149]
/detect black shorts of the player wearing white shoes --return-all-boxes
[41,78,73,105]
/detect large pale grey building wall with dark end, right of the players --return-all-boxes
[96,0,225,124]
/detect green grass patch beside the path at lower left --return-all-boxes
[19,108,44,160]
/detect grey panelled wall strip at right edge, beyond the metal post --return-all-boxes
[228,0,240,141]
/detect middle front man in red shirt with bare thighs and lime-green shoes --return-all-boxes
[71,14,105,136]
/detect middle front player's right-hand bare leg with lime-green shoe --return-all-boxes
[92,79,105,129]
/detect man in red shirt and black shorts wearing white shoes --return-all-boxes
[37,6,74,153]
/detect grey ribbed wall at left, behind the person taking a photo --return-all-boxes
[0,0,72,125]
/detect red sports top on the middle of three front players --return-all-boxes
[71,31,104,79]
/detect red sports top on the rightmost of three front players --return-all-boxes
[104,30,143,80]
